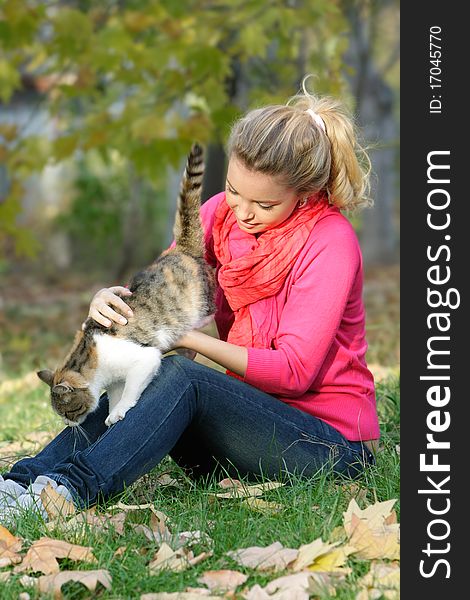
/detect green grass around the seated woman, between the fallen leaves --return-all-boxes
[0,377,400,600]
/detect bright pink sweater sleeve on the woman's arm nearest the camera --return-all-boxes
[244,219,361,398]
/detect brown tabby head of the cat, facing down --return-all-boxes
[37,369,96,427]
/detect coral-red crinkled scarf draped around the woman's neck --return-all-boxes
[213,196,328,348]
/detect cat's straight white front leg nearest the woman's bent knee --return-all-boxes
[105,347,161,427]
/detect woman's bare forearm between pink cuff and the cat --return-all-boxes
[177,330,248,377]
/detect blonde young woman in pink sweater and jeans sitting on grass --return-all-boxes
[0,84,379,518]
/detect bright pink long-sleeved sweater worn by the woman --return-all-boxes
[201,192,380,441]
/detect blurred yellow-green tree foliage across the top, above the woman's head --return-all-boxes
[0,0,346,262]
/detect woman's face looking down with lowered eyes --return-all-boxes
[225,157,300,234]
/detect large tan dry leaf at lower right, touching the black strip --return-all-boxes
[349,514,400,560]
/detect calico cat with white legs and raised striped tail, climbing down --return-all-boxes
[38,144,215,426]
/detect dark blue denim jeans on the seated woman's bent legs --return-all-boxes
[4,355,374,506]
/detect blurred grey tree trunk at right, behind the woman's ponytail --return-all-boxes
[343,0,399,264]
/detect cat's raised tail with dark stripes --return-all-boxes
[173,144,204,257]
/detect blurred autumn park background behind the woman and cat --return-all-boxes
[0,0,399,390]
